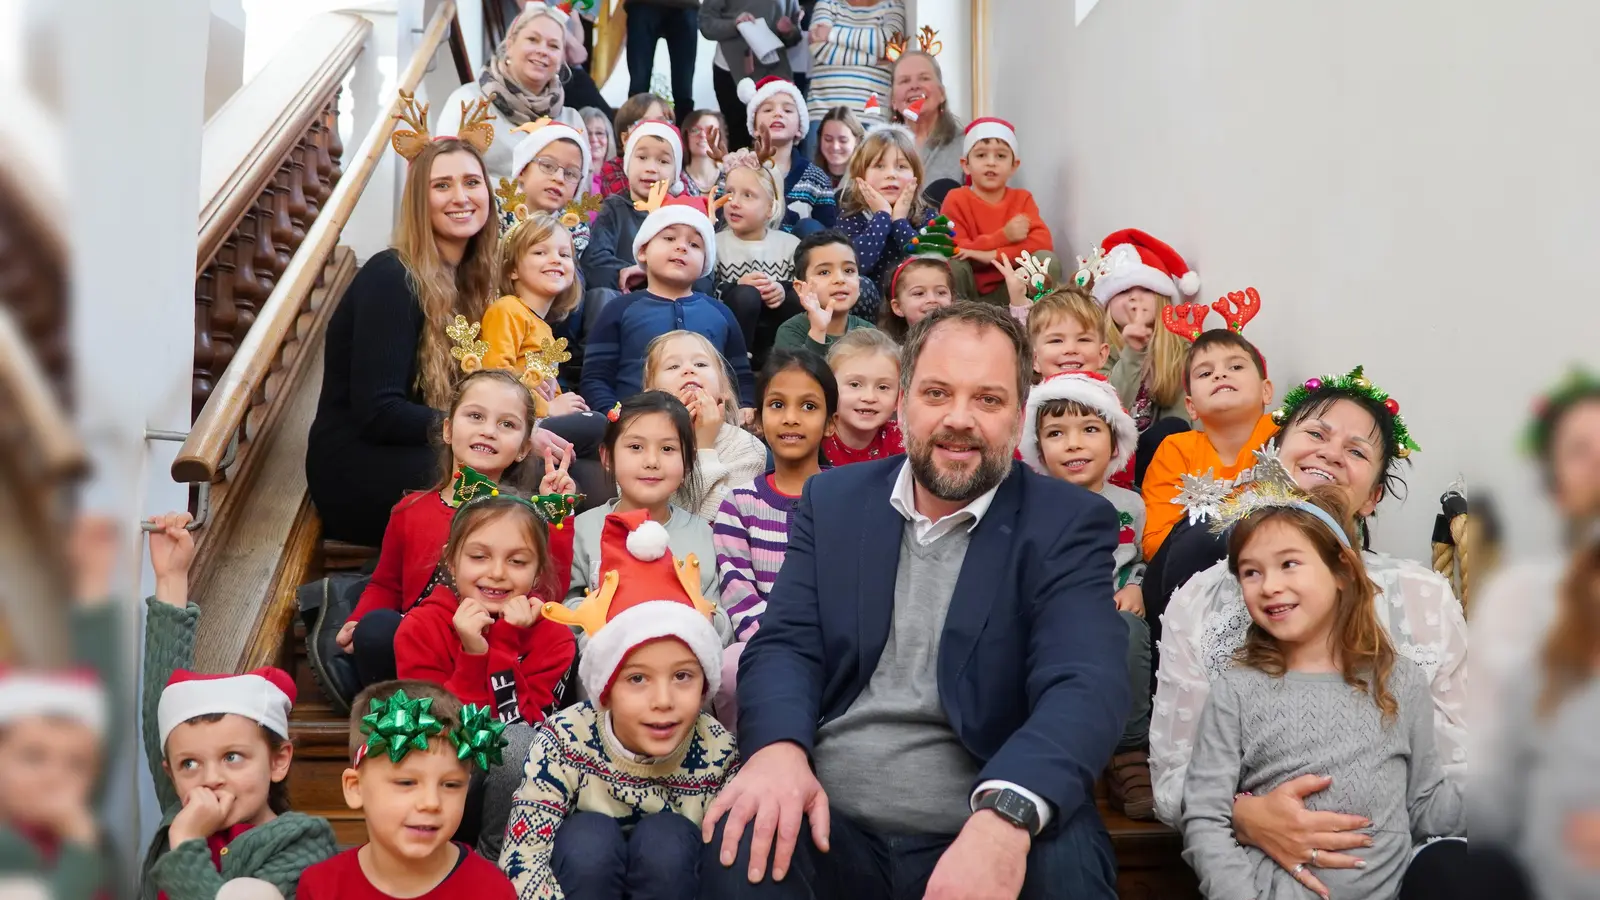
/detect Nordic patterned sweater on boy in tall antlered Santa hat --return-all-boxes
[499,703,739,900]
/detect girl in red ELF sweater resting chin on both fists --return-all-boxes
[395,492,578,724]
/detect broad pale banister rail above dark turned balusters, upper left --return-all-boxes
[195,13,373,274]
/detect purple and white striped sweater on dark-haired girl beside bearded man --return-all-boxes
[712,472,800,641]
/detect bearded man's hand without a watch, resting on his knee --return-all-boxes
[701,741,829,884]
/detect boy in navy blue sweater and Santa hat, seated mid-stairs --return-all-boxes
[579,195,755,410]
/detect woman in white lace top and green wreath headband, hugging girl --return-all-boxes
[1150,370,1467,886]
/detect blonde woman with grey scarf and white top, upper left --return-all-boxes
[434,3,586,186]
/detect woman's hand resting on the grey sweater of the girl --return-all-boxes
[1234,775,1373,898]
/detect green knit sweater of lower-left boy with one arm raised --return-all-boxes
[139,597,339,900]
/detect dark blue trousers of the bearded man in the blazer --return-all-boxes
[701,802,1117,900]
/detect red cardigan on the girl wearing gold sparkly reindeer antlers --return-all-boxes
[347,490,573,621]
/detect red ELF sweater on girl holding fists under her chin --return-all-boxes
[395,582,578,722]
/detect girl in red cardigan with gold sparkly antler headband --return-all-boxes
[338,370,576,685]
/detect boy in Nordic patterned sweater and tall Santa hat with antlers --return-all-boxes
[499,509,739,900]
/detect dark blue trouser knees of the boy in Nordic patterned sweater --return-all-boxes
[550,812,701,900]
